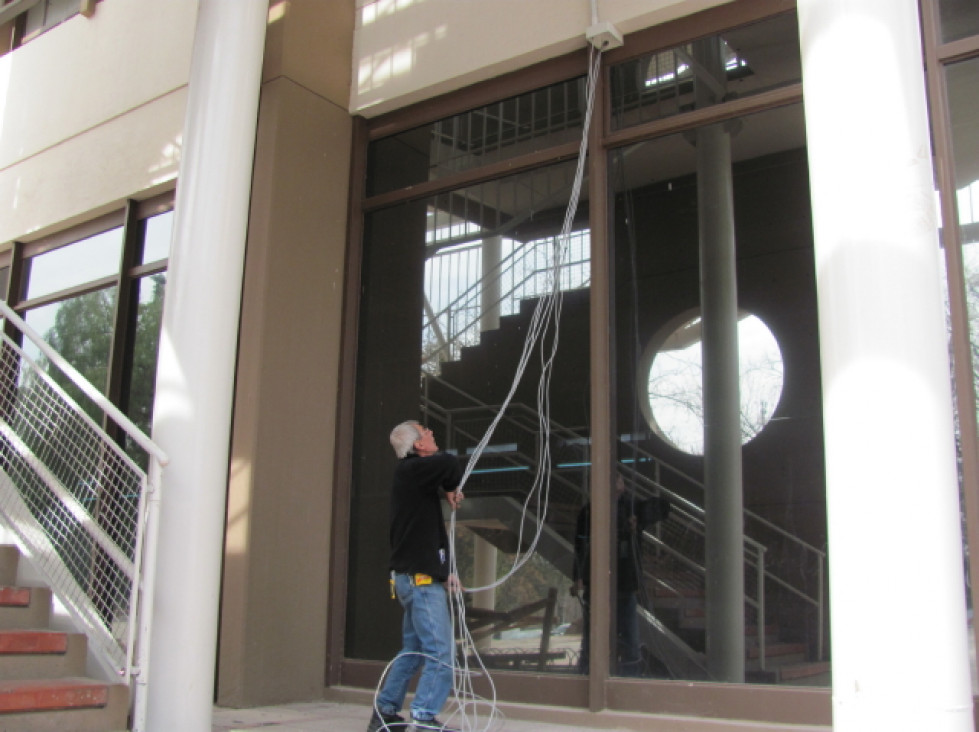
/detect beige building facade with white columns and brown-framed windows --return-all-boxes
[0,0,979,730]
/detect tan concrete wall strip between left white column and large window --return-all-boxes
[218,0,353,706]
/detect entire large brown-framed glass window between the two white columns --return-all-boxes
[344,2,830,716]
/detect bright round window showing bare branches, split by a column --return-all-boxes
[640,313,783,455]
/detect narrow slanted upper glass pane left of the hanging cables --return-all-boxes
[367,79,585,195]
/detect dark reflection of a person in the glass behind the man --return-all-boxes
[571,475,670,676]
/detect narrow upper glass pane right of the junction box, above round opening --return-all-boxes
[611,13,802,129]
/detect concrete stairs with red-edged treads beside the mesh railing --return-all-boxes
[0,545,129,732]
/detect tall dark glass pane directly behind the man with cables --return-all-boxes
[346,162,591,673]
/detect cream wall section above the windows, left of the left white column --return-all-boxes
[0,0,197,243]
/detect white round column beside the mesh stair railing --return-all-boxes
[147,5,268,732]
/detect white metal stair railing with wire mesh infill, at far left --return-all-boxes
[0,302,167,729]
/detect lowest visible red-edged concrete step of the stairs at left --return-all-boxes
[0,678,129,732]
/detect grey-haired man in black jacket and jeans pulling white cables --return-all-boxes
[367,421,463,732]
